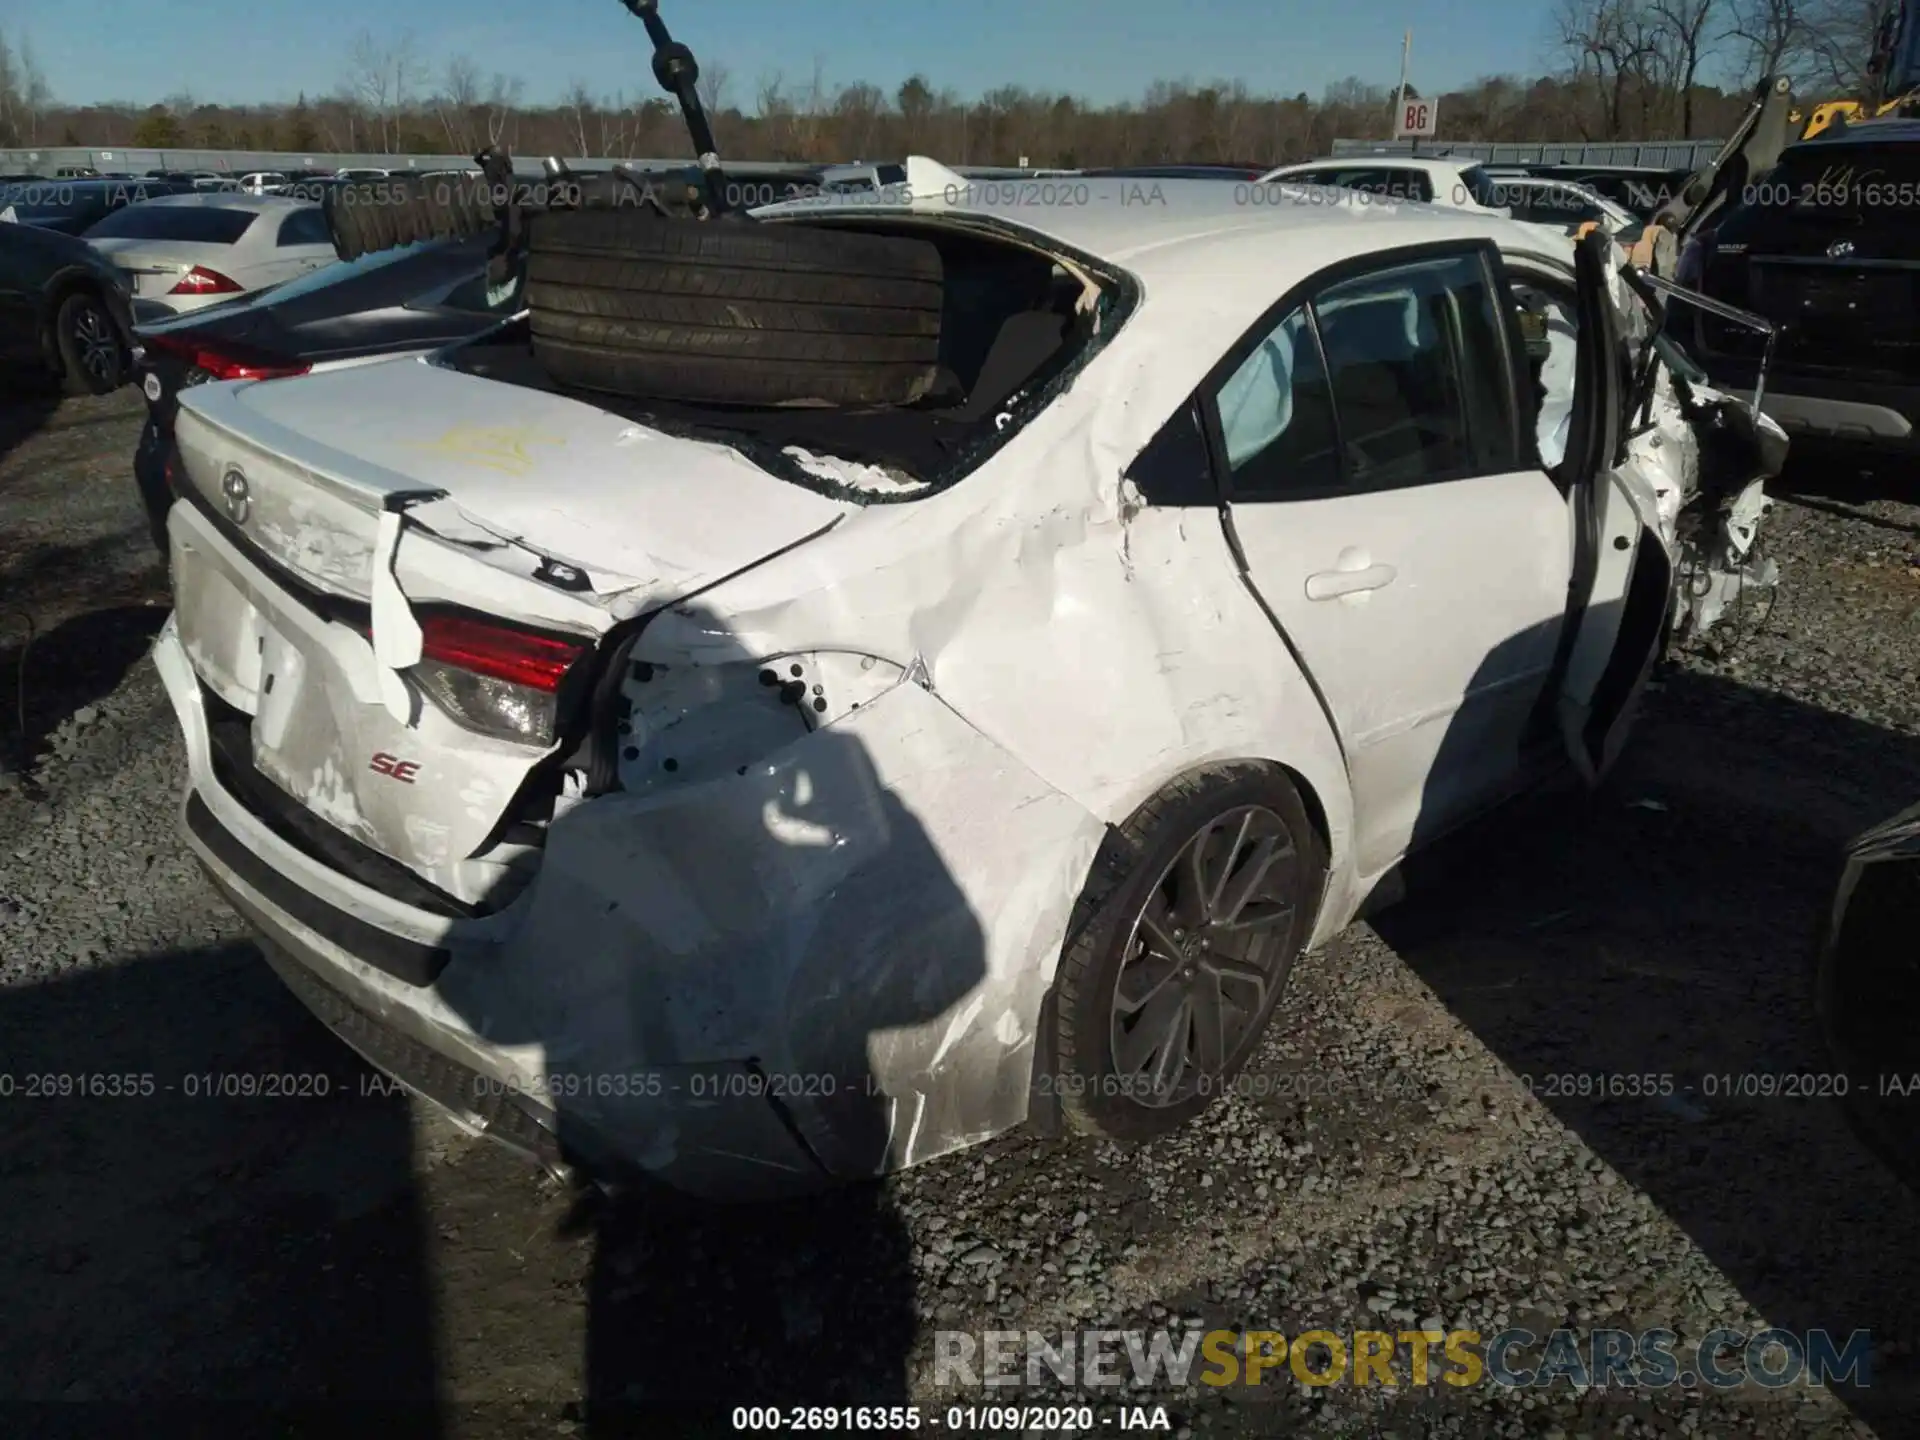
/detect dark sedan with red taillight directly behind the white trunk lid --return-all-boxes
[132,236,520,555]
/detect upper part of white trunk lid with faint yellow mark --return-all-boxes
[177,359,854,607]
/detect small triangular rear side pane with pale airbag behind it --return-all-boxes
[1213,307,1340,499]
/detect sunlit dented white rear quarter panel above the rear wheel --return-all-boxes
[645,311,1352,940]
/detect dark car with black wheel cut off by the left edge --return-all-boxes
[0,225,132,396]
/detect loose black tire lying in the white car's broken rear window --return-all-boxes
[526,209,943,405]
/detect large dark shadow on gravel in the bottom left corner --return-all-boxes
[0,936,438,1436]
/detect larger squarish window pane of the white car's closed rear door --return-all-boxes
[1313,255,1515,488]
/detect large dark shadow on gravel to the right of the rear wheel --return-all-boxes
[1375,672,1920,1434]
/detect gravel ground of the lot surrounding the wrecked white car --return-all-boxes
[0,394,1920,1440]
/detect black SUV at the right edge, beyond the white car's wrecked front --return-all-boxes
[1668,119,1920,461]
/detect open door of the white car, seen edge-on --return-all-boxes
[1559,234,1674,783]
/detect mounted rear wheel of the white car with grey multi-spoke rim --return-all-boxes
[1052,762,1327,1142]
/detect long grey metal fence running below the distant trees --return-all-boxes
[0,140,1724,177]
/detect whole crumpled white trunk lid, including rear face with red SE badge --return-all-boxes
[169,361,849,904]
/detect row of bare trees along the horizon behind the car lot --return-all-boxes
[0,0,1885,167]
